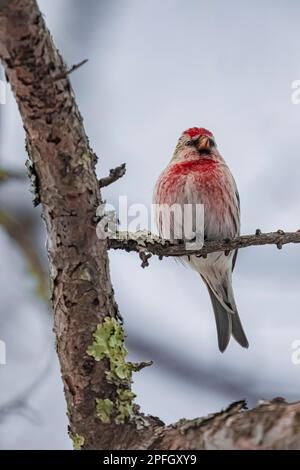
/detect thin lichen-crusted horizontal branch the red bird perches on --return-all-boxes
[108,230,300,258]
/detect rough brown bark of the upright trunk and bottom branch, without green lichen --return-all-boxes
[0,0,300,449]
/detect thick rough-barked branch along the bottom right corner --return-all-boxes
[151,398,300,450]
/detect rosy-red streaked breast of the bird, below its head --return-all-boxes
[154,158,239,239]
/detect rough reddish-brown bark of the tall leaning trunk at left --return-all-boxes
[0,0,157,448]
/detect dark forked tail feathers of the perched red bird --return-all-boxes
[207,286,249,352]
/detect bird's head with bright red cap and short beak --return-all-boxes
[173,127,217,160]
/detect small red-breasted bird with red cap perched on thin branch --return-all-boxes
[153,127,249,352]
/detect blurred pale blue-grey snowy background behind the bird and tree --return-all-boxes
[0,0,300,449]
